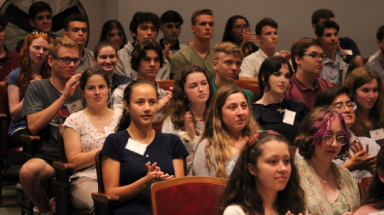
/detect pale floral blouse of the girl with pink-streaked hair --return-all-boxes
[297,159,360,215]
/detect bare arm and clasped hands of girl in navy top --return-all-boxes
[102,155,173,202]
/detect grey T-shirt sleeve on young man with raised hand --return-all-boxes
[21,81,44,117]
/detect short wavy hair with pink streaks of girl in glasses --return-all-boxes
[295,107,351,160]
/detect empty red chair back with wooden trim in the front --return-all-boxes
[150,176,228,215]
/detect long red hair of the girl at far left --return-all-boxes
[17,33,52,99]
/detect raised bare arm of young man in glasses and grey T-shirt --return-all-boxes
[27,74,81,134]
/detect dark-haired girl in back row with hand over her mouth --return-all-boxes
[222,15,259,57]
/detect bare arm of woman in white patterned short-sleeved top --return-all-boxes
[63,127,102,170]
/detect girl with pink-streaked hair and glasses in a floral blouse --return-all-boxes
[295,107,360,215]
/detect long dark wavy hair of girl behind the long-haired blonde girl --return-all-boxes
[164,65,214,131]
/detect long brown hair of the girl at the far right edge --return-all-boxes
[345,67,384,136]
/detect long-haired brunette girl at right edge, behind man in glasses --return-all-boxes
[345,68,384,145]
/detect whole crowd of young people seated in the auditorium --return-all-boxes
[0,1,384,215]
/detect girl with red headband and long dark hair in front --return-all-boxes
[219,130,305,215]
